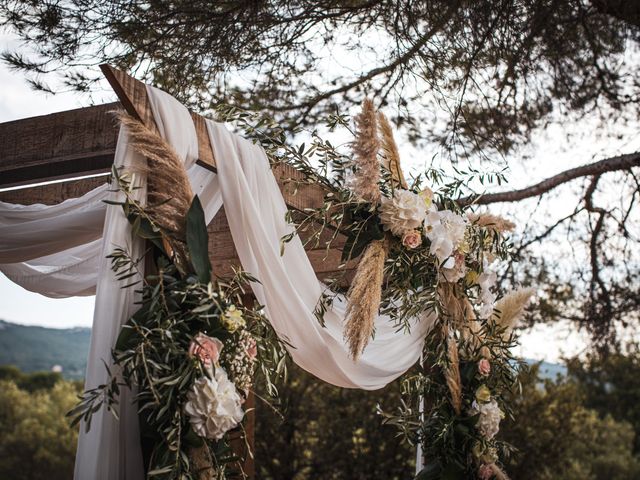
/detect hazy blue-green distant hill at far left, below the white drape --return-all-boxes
[0,320,91,379]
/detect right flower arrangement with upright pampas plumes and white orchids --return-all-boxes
[224,100,533,479]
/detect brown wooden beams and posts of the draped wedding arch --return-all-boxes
[0,65,355,478]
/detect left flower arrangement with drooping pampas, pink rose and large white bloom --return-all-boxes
[70,117,286,480]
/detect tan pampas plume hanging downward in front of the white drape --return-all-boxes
[344,239,389,360]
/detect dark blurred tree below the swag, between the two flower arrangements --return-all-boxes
[256,366,415,480]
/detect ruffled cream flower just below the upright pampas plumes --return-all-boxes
[380,189,426,237]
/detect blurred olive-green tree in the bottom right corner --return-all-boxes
[500,366,640,480]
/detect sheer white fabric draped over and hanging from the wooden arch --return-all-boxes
[0,87,433,480]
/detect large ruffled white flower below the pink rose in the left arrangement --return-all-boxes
[184,367,244,440]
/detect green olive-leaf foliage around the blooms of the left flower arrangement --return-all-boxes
[68,167,286,480]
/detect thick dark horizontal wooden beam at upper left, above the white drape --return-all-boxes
[0,103,120,187]
